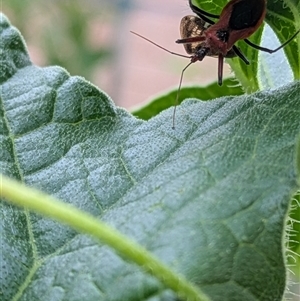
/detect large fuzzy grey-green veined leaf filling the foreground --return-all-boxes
[0,12,300,301]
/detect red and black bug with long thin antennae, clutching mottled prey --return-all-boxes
[132,0,300,128]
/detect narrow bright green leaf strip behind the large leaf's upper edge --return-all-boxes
[132,79,243,120]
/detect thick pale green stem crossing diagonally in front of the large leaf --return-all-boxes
[0,174,210,301]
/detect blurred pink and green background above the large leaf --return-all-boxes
[1,0,229,109]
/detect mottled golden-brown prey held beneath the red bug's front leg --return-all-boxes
[180,16,210,54]
